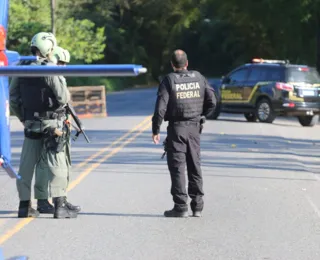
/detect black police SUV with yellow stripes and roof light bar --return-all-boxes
[212,59,320,126]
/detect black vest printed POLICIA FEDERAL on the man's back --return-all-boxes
[164,71,204,121]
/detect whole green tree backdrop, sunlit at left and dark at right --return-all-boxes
[8,0,320,91]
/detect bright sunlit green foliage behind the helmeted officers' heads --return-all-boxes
[8,0,106,63]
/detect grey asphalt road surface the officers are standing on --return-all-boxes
[0,89,320,260]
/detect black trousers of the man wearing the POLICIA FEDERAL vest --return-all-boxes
[167,121,204,211]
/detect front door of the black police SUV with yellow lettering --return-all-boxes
[221,68,249,107]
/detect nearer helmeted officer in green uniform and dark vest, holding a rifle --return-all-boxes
[10,32,77,218]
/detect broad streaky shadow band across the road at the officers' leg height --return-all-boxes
[7,130,320,177]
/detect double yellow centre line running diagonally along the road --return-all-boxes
[0,116,151,245]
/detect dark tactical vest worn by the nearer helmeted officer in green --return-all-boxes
[18,77,59,120]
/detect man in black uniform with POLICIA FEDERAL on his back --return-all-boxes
[152,50,216,217]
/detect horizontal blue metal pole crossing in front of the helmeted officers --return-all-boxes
[0,64,147,77]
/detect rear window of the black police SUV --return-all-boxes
[287,67,320,84]
